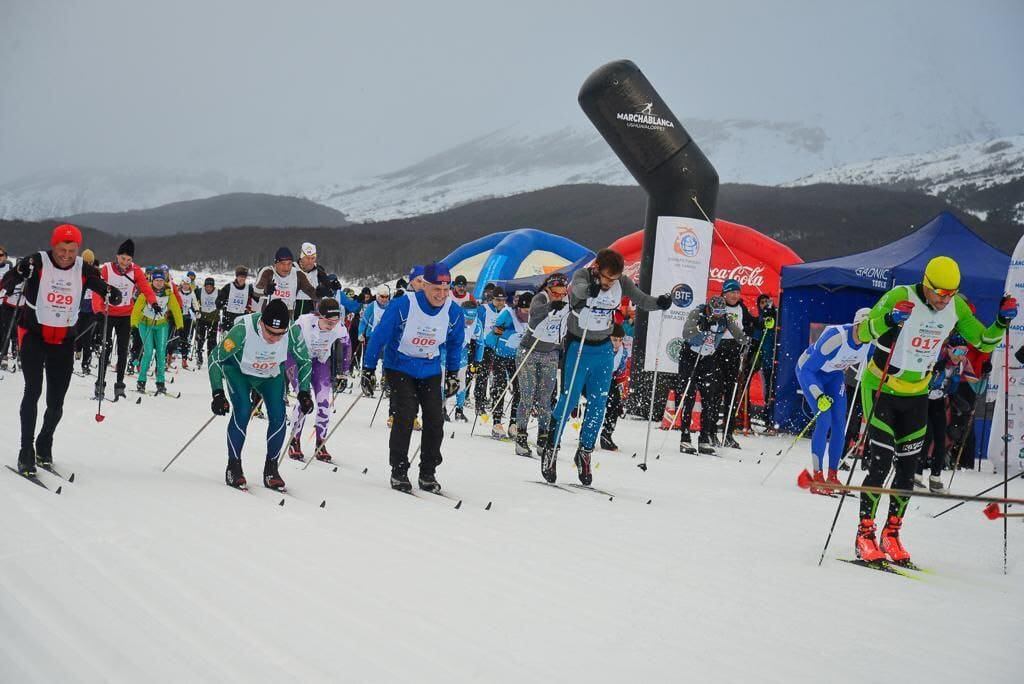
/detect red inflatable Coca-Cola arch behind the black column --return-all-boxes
[610,219,804,310]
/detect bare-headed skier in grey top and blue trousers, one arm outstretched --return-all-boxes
[541,249,672,485]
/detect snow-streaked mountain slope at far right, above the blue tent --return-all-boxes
[786,135,1024,223]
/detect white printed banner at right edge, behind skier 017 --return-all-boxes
[987,238,1024,468]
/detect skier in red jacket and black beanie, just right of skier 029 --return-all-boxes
[92,240,161,399]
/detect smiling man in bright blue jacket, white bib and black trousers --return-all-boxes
[362,263,466,494]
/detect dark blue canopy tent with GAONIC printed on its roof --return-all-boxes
[774,212,1010,432]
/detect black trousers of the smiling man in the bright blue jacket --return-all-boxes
[384,369,444,475]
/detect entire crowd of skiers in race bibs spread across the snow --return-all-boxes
[0,224,1017,562]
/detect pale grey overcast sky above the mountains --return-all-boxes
[0,0,1024,181]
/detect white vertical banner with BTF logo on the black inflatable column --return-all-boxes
[644,216,715,373]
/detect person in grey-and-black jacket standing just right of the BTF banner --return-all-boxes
[676,296,745,456]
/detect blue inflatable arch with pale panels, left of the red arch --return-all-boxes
[443,228,594,297]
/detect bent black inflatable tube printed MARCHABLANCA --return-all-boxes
[578,59,718,416]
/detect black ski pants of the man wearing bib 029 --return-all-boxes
[22,330,75,453]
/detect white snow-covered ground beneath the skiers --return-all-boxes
[0,372,1024,684]
